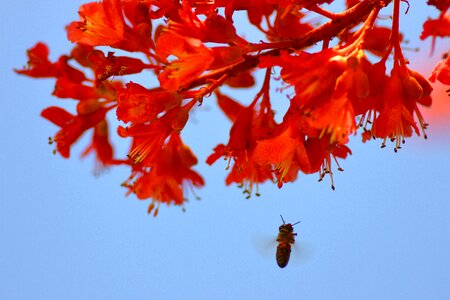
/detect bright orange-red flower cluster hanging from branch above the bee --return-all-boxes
[16,0,450,215]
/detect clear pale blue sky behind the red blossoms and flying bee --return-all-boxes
[0,0,450,300]
